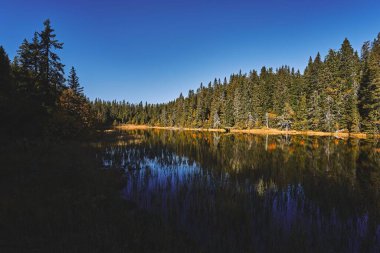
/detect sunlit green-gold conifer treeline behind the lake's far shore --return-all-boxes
[93,34,380,133]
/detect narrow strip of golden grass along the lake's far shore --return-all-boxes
[115,124,372,139]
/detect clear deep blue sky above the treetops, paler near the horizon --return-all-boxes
[0,0,380,103]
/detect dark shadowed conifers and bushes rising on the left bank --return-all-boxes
[0,20,96,138]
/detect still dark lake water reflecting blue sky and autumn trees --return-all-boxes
[99,130,380,252]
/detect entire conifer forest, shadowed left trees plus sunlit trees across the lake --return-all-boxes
[0,20,380,138]
